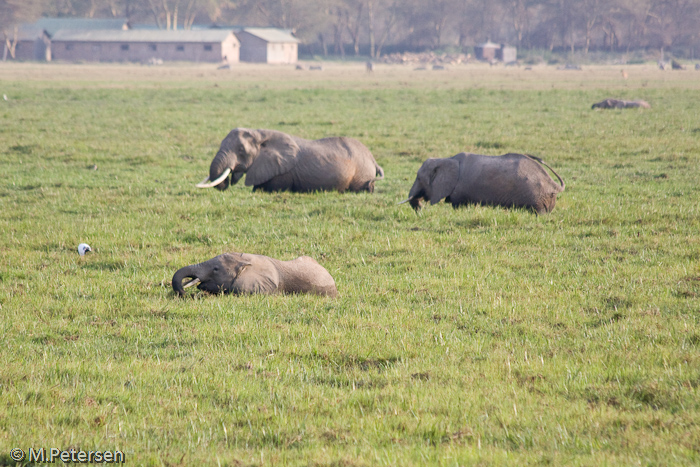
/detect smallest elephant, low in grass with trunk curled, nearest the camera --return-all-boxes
[173,253,338,297]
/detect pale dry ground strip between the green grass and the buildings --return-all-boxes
[0,62,700,91]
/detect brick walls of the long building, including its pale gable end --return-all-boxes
[51,35,239,63]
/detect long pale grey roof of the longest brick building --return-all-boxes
[52,29,233,42]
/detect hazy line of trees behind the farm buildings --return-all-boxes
[0,0,700,57]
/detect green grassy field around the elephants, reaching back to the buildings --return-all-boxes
[0,64,700,466]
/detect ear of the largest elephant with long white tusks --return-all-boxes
[245,131,299,186]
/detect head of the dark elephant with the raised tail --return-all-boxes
[399,158,459,210]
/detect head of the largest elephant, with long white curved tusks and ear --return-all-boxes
[197,128,299,190]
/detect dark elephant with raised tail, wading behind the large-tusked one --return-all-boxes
[399,152,566,214]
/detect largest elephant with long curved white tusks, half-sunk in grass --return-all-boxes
[197,128,384,193]
